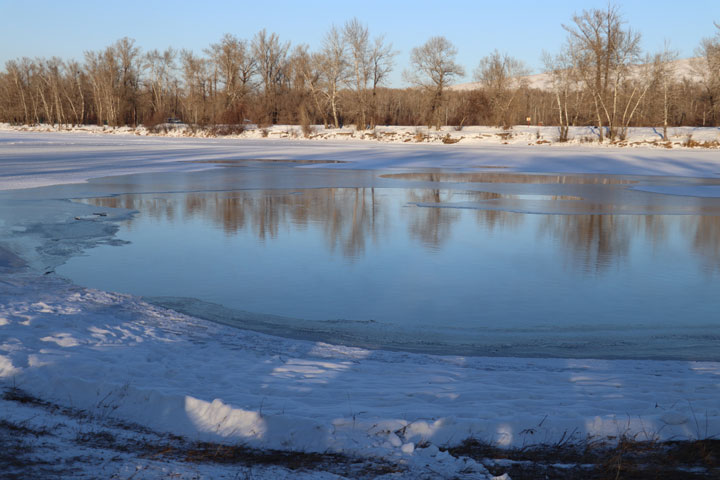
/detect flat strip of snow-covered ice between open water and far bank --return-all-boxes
[0,130,720,190]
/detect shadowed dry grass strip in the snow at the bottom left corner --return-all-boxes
[0,388,406,479]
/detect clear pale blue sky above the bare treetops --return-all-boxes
[0,0,720,86]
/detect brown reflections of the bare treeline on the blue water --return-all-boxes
[88,191,720,271]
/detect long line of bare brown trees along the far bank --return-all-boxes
[0,5,720,133]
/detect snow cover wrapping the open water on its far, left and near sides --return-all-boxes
[0,131,720,478]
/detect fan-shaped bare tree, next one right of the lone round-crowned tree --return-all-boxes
[475,50,528,128]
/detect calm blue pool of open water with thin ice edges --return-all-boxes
[50,162,720,360]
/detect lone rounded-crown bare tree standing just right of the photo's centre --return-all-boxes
[404,37,465,130]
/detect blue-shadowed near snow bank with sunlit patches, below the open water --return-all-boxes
[0,274,720,461]
